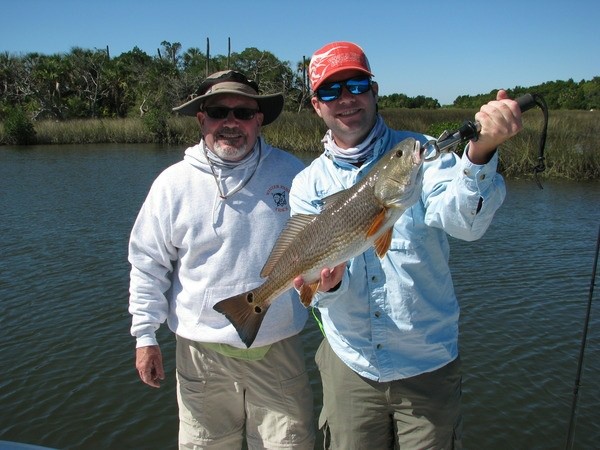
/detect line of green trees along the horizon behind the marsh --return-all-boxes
[0,41,600,122]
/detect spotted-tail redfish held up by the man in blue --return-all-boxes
[213,138,424,347]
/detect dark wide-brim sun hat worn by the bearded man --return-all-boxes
[173,70,283,125]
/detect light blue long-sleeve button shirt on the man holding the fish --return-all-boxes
[290,124,506,382]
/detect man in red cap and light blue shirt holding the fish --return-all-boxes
[290,42,521,450]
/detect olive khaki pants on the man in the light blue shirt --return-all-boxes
[315,339,462,450]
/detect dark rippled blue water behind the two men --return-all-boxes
[0,145,600,449]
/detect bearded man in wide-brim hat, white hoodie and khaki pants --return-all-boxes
[129,70,315,450]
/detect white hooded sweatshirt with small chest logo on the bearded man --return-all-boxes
[129,138,307,348]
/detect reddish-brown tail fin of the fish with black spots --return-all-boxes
[213,291,269,347]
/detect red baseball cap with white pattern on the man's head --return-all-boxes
[308,41,373,92]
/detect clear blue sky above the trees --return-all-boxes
[0,0,600,104]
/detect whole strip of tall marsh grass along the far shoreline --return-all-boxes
[0,109,600,180]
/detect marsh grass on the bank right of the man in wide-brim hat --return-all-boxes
[272,109,600,180]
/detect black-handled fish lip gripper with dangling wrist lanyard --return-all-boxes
[424,94,548,189]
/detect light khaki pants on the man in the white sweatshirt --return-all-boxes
[176,336,315,450]
